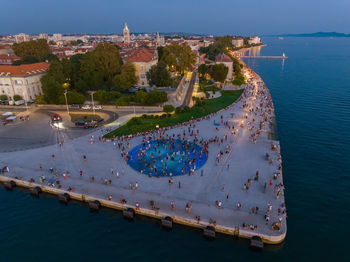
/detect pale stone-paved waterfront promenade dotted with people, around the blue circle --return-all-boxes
[0,66,287,243]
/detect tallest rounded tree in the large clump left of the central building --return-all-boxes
[80,43,122,92]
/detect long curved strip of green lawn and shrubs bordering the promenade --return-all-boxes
[105,90,243,138]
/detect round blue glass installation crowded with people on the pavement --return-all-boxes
[128,139,207,176]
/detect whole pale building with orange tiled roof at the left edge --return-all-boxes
[0,62,50,101]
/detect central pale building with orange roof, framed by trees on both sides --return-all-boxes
[124,48,158,87]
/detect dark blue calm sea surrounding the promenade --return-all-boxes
[0,38,350,262]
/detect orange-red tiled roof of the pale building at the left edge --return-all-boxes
[0,62,50,76]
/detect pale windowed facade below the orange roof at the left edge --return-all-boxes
[0,73,44,101]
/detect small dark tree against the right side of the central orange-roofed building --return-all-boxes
[146,61,172,87]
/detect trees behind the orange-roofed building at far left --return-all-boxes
[12,39,51,61]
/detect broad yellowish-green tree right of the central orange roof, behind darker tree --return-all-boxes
[162,43,196,73]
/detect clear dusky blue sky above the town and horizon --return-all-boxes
[0,0,350,35]
